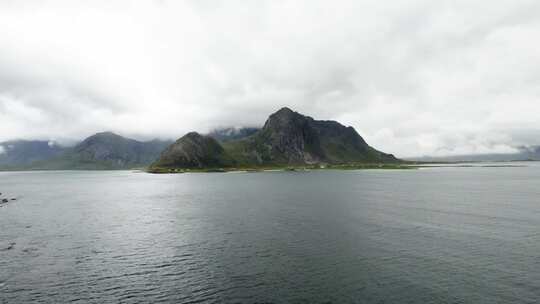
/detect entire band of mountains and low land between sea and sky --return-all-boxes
[0,108,540,170]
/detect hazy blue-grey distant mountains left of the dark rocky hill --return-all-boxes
[2,132,172,170]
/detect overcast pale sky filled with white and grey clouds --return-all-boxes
[0,0,540,157]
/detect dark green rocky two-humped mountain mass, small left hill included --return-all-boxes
[151,108,399,170]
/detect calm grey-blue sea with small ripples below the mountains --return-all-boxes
[0,165,540,304]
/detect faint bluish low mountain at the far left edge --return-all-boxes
[0,140,66,168]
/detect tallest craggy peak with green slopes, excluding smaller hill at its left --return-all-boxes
[224,108,398,165]
